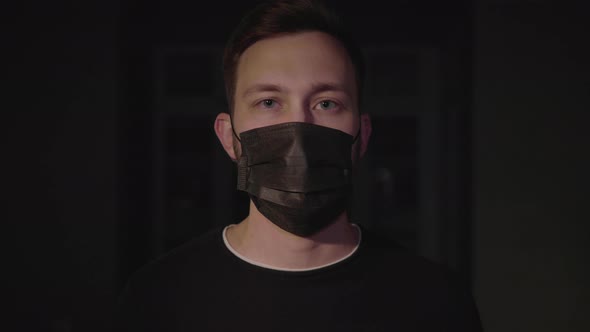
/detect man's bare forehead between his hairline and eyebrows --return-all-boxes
[236,31,355,98]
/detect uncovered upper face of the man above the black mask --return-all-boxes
[216,31,370,159]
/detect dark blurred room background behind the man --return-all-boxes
[5,0,590,332]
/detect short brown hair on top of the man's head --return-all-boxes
[223,0,364,114]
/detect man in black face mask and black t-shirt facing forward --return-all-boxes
[113,1,481,332]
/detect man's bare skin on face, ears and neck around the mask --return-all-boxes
[214,31,371,269]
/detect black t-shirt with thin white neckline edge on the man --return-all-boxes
[116,224,481,332]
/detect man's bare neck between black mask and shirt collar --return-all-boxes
[226,202,360,269]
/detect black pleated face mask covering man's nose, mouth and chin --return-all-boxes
[238,122,358,236]
